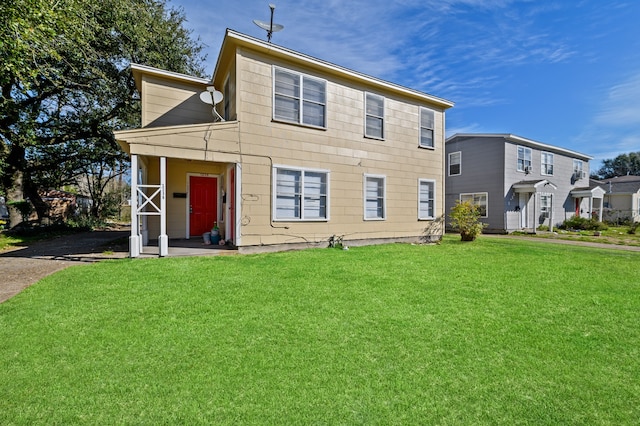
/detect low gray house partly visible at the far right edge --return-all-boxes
[591,175,640,222]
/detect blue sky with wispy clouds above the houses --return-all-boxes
[168,0,640,170]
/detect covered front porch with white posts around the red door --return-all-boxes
[116,122,241,257]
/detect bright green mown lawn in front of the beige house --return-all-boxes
[0,236,640,425]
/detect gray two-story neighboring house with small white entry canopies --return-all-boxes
[445,134,605,233]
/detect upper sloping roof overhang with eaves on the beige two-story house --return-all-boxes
[213,29,454,109]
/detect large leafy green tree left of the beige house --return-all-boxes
[0,0,203,223]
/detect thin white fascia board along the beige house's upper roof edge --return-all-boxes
[213,29,454,109]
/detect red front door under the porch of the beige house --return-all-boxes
[189,176,218,236]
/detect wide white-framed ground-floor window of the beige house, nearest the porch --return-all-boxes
[273,167,329,220]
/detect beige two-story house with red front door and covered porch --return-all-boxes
[116,30,453,257]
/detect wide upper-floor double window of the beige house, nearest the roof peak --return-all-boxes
[273,68,327,127]
